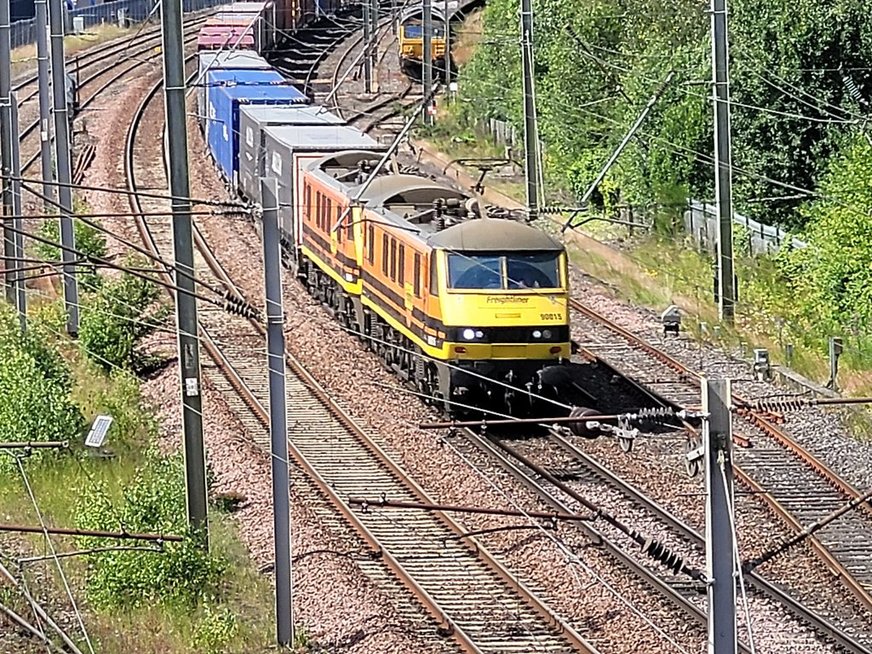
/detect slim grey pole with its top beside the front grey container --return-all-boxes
[260,179,294,646]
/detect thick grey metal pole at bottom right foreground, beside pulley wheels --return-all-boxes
[702,379,738,654]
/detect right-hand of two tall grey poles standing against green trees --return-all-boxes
[711,0,736,325]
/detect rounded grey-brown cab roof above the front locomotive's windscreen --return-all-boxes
[427,218,563,252]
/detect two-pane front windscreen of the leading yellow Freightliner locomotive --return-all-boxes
[448,252,561,291]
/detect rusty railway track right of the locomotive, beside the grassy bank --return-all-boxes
[572,301,872,624]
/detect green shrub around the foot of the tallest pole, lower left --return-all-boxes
[76,449,227,609]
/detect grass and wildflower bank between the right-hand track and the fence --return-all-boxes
[420,108,872,410]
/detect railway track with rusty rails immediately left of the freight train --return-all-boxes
[125,62,596,654]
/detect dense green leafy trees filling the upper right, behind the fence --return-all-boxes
[460,0,872,227]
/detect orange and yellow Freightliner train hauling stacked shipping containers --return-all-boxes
[198,3,573,414]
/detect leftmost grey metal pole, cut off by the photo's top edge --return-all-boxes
[0,0,17,305]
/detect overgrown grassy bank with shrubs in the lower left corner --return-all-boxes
[0,298,273,654]
